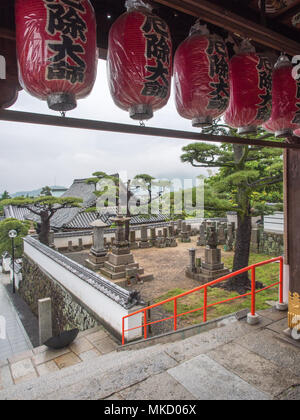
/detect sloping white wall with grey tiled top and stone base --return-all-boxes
[20,236,142,341]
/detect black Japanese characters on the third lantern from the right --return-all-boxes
[207,39,229,111]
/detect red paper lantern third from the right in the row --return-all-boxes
[174,22,229,127]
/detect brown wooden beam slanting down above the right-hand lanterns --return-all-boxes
[156,0,300,56]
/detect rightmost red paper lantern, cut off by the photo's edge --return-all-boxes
[263,55,300,137]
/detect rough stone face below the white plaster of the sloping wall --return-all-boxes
[19,256,98,334]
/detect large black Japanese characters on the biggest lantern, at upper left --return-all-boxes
[44,0,87,84]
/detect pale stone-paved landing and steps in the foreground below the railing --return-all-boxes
[0,308,300,401]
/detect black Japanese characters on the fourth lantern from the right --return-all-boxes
[142,16,170,99]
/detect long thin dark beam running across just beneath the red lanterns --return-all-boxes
[0,110,300,149]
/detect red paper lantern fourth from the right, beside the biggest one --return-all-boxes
[107,0,172,120]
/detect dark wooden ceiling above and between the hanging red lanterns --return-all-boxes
[0,0,300,56]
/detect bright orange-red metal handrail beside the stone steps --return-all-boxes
[122,257,283,345]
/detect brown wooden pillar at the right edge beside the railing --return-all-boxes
[284,149,300,329]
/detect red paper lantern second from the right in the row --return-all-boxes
[224,41,272,134]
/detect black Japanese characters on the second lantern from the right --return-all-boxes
[256,57,272,121]
